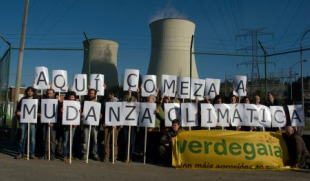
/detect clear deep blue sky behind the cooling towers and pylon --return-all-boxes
[0,0,310,86]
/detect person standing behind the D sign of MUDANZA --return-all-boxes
[59,91,77,162]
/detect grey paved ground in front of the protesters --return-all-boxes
[0,145,310,181]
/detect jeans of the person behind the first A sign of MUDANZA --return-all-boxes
[82,125,98,157]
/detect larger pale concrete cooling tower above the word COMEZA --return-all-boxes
[148,19,198,88]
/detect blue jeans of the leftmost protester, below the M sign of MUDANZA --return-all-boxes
[18,123,36,156]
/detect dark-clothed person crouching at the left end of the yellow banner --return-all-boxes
[159,119,182,164]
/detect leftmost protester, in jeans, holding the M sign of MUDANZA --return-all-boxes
[15,87,39,159]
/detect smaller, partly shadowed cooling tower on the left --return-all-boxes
[82,39,118,88]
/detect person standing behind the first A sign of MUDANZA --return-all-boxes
[82,89,102,161]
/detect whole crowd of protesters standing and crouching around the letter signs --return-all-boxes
[15,87,310,167]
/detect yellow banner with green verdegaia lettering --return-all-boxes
[172,130,288,170]
